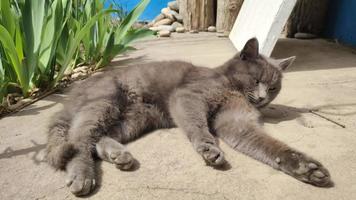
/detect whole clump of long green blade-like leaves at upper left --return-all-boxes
[0,0,153,103]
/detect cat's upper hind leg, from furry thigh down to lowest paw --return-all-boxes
[66,97,120,196]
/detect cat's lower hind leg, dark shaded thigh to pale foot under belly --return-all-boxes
[96,103,169,170]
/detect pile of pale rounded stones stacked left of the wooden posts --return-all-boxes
[148,1,185,37]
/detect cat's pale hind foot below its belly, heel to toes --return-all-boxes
[96,136,134,170]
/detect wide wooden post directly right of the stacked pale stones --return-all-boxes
[179,0,216,31]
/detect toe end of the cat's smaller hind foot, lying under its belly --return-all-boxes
[110,150,135,170]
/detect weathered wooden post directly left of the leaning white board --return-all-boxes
[216,0,244,32]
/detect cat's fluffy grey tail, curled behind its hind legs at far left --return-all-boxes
[46,112,77,170]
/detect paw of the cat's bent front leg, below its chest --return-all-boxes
[198,143,226,166]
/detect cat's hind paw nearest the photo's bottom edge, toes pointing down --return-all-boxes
[66,170,96,196]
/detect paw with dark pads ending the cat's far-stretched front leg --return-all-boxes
[276,150,334,187]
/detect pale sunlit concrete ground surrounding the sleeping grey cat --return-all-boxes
[0,33,356,200]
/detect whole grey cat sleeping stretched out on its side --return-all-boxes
[47,38,332,196]
